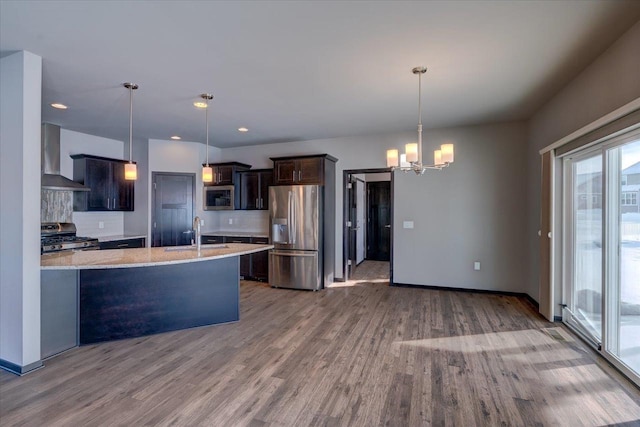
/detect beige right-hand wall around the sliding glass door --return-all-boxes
[525,22,640,301]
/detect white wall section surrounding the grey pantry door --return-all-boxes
[147,139,220,241]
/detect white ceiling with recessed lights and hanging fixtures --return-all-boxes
[0,0,640,147]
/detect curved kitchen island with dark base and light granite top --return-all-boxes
[41,243,273,358]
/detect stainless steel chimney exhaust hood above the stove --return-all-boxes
[40,123,91,191]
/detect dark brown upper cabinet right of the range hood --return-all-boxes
[71,154,135,211]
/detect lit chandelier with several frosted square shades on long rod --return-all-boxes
[387,67,453,175]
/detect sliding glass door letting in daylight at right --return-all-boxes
[562,131,640,383]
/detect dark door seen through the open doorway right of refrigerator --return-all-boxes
[367,181,391,261]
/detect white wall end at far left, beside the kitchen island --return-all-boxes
[0,52,42,369]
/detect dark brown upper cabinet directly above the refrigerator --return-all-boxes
[271,154,338,185]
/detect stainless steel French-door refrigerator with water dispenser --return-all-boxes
[269,185,324,291]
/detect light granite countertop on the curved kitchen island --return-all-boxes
[40,243,273,270]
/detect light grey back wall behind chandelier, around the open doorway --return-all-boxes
[221,123,526,292]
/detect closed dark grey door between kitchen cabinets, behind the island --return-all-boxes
[151,172,195,246]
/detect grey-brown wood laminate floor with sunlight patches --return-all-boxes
[0,280,640,426]
